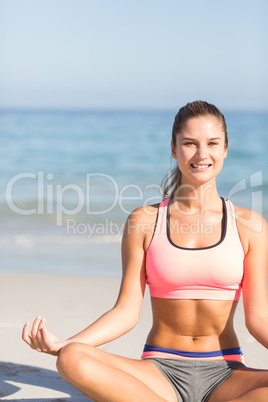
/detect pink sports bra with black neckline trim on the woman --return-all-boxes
[146,198,244,300]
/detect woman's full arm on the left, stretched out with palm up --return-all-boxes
[22,208,152,355]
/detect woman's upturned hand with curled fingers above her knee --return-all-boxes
[22,317,67,356]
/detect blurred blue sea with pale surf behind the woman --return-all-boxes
[0,110,268,277]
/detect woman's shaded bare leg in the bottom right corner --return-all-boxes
[208,367,268,402]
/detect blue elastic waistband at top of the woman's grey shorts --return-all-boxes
[143,345,243,358]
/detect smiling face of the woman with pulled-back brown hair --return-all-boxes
[171,115,227,184]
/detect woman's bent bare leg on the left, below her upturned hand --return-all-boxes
[57,343,177,402]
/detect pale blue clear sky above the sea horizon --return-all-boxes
[0,0,268,110]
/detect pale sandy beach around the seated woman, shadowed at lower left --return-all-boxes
[0,273,268,402]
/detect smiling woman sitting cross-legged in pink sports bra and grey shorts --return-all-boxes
[23,101,268,402]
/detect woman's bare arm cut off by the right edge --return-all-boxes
[239,211,268,348]
